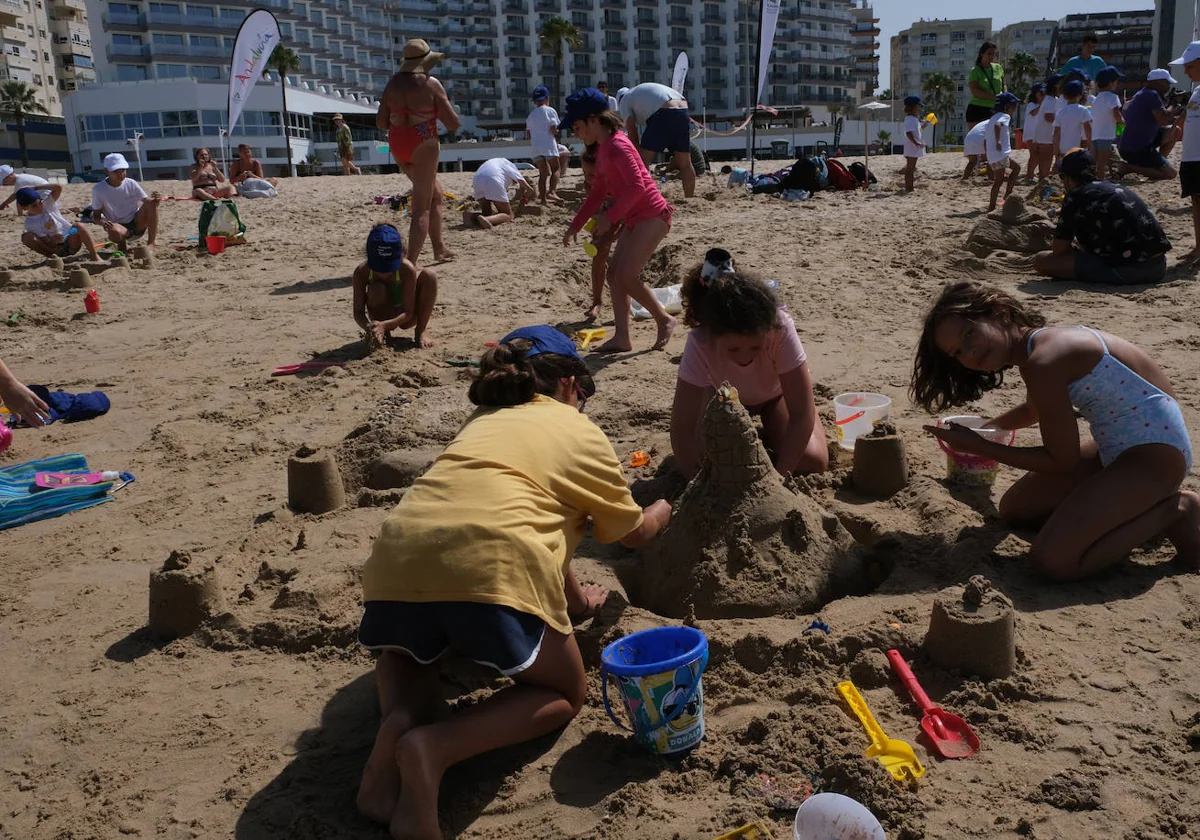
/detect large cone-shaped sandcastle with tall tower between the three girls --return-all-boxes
[630,384,866,618]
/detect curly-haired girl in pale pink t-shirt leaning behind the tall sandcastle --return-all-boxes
[671,248,829,476]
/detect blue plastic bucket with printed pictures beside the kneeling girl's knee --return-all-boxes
[600,628,708,755]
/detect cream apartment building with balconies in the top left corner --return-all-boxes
[0,0,94,116]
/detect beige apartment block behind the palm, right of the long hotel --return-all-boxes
[890,18,991,137]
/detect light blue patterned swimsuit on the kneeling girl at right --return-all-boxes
[1027,326,1192,472]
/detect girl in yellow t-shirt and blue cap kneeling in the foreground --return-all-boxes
[358,326,671,840]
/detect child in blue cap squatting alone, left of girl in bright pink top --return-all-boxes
[352,222,438,348]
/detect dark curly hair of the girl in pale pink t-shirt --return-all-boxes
[680,263,779,336]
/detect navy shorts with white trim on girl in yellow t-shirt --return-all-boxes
[359,601,546,677]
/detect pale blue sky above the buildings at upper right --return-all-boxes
[875,0,1156,90]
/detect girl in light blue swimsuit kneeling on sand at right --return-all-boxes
[911,282,1200,580]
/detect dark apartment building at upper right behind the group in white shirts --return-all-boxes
[1052,10,1156,87]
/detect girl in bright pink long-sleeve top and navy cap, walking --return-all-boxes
[559,88,676,353]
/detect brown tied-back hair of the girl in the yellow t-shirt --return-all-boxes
[467,338,596,408]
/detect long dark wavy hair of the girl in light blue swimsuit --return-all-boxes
[908,281,1046,413]
